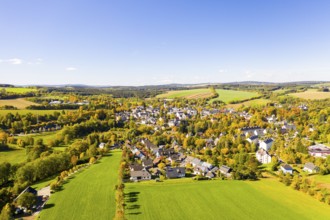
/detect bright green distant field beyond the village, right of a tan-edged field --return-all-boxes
[211,89,260,103]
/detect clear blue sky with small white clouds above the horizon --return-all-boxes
[0,0,330,85]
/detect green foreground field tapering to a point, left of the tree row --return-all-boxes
[39,150,121,220]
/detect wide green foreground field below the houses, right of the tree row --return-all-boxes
[125,179,330,220]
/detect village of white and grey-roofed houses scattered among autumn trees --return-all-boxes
[116,104,330,181]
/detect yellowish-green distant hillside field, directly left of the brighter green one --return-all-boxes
[156,89,212,99]
